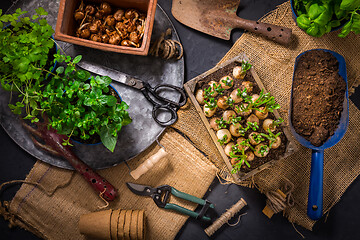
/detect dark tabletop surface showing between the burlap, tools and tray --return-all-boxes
[0,0,360,240]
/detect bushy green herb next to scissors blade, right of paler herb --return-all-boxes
[40,52,131,151]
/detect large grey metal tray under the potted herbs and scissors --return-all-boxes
[0,0,184,169]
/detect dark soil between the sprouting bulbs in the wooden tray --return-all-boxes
[196,62,288,173]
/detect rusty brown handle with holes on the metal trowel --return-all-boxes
[234,18,292,45]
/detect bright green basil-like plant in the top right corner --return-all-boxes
[294,0,360,37]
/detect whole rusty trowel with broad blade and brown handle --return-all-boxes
[171,0,291,44]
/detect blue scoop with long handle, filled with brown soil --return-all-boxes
[289,49,349,220]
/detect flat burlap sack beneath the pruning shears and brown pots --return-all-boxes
[10,129,217,240]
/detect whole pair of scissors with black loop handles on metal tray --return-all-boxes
[77,61,186,127]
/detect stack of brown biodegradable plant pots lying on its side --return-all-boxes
[79,209,145,240]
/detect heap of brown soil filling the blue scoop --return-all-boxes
[291,50,346,147]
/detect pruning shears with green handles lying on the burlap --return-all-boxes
[126,183,214,221]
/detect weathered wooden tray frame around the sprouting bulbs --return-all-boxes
[185,54,296,182]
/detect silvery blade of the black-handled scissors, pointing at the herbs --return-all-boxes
[77,61,143,89]
